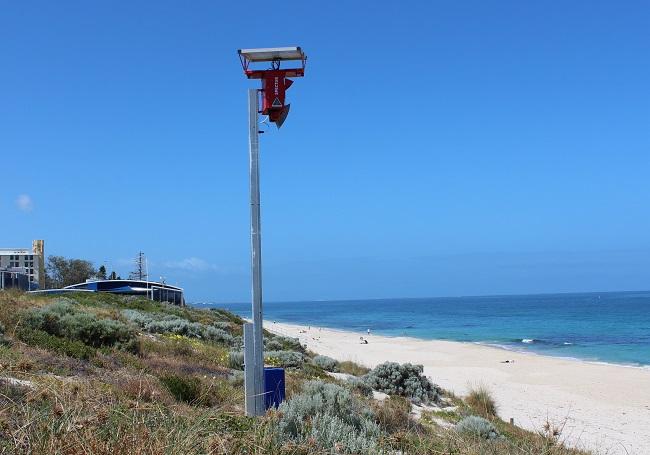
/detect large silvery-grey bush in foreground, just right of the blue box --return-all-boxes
[277,381,381,454]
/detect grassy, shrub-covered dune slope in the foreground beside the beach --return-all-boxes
[0,292,584,455]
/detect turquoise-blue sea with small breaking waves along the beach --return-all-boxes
[210,292,650,366]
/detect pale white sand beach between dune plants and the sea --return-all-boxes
[265,321,650,455]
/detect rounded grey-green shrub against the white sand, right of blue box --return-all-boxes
[364,362,440,403]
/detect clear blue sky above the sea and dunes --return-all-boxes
[0,1,650,302]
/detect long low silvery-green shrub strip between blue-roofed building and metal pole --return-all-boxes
[122,309,234,344]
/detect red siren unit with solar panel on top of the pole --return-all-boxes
[239,47,307,128]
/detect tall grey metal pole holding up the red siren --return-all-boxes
[244,89,265,415]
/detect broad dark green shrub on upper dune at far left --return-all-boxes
[25,301,135,348]
